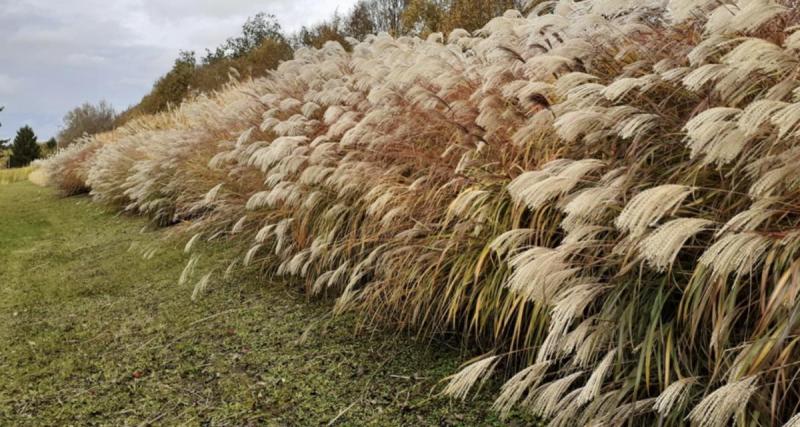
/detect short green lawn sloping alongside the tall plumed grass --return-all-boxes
[0,183,524,425]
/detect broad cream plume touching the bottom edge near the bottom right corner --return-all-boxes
[689,376,758,427]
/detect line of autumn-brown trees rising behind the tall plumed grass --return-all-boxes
[58,0,522,146]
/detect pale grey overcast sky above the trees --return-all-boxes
[0,0,355,140]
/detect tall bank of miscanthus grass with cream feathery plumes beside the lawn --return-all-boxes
[45,0,800,426]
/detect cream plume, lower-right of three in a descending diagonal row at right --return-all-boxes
[697,232,772,278]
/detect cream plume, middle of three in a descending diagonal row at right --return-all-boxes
[639,218,714,272]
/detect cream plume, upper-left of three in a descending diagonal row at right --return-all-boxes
[614,184,694,236]
